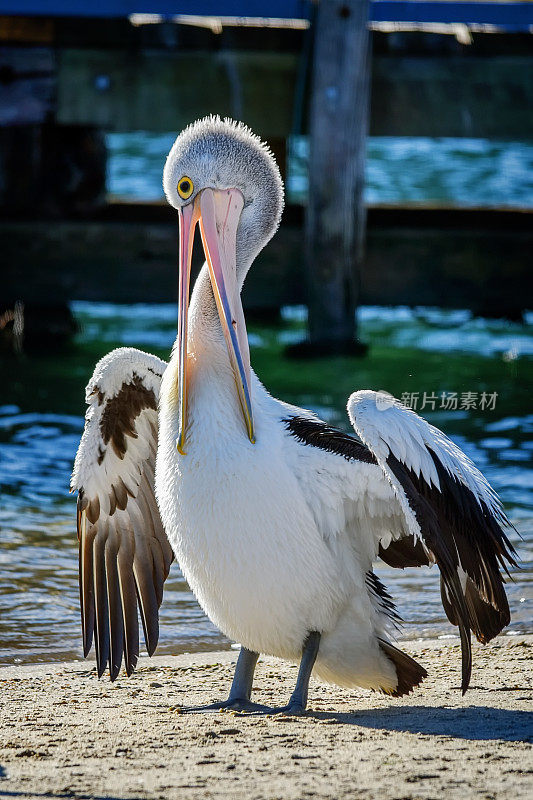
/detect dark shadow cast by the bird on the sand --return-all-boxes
[309,706,533,742]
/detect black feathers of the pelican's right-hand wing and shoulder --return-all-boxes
[283,416,516,693]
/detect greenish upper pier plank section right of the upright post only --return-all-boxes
[370,55,533,140]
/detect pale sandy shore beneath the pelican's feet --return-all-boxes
[0,636,533,800]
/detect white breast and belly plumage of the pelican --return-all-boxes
[156,352,396,688]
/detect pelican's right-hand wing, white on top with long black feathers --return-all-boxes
[348,391,516,693]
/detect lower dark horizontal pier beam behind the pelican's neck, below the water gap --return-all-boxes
[0,205,533,317]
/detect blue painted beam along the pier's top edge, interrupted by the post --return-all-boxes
[0,0,533,31]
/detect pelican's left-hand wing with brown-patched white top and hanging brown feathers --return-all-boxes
[71,348,173,680]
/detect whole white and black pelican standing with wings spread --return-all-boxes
[72,116,515,714]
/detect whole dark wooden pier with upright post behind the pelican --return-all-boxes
[0,0,533,349]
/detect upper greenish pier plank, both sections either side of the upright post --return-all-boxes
[52,48,533,140]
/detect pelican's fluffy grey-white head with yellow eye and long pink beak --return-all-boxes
[163,117,283,454]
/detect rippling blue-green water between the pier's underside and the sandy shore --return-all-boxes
[0,303,533,663]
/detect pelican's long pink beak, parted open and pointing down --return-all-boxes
[176,184,255,455]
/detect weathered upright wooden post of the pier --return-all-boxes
[301,0,370,355]
